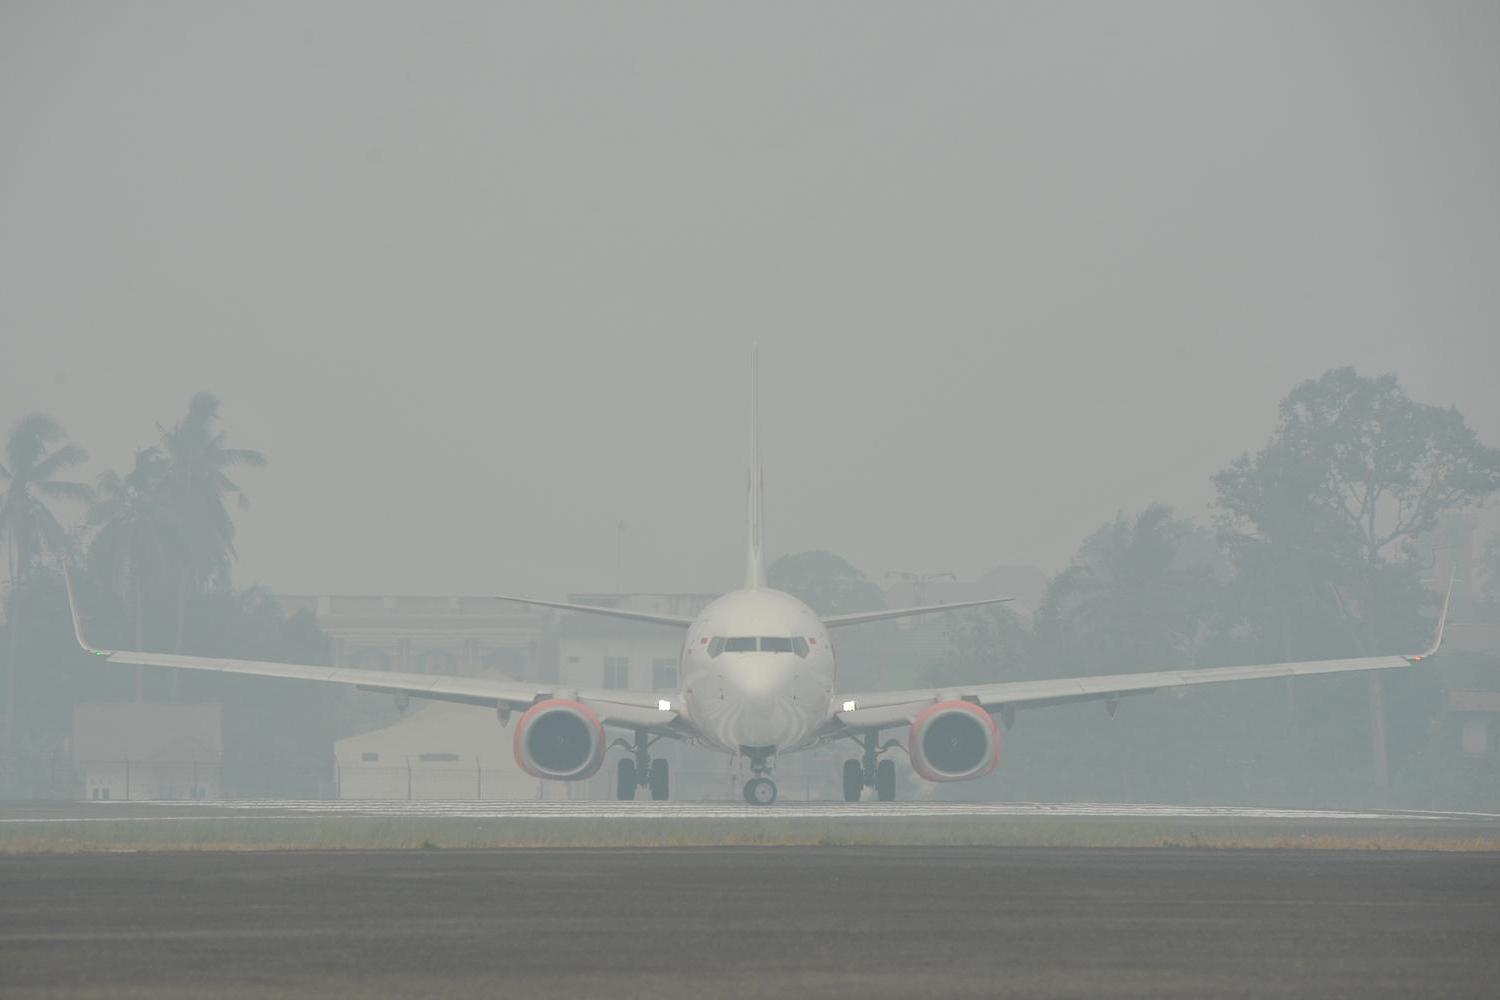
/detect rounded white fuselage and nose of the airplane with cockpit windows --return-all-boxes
[681,588,837,753]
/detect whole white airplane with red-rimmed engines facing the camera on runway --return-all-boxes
[65,354,1452,805]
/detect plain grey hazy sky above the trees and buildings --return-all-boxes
[0,0,1500,594]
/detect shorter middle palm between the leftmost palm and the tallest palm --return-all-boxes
[89,448,180,702]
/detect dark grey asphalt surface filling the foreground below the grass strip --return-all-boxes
[0,847,1500,997]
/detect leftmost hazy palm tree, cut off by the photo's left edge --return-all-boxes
[0,414,93,747]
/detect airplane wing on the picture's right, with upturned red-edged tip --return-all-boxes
[831,583,1452,735]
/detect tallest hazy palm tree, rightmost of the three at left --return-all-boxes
[158,393,266,659]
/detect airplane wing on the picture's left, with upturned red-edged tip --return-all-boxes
[68,577,689,736]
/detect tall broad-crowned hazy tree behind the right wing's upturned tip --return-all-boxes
[1214,367,1500,795]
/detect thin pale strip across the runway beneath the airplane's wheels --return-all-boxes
[0,799,1500,825]
